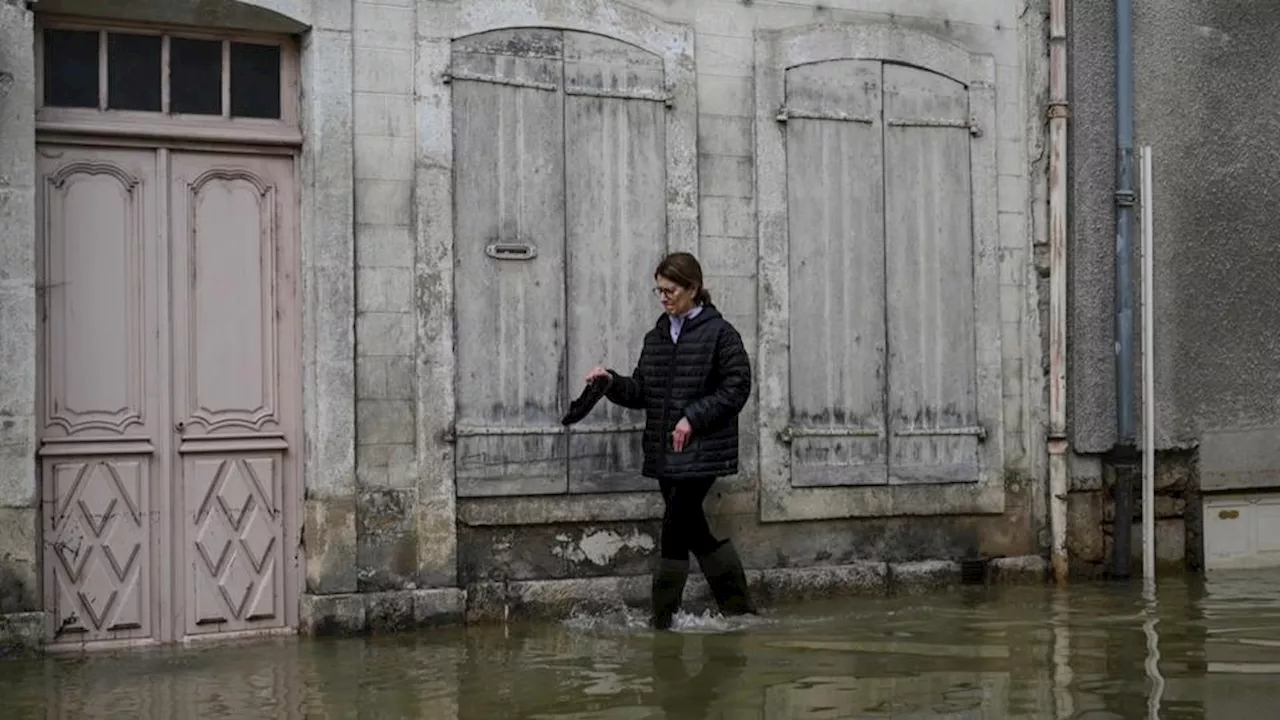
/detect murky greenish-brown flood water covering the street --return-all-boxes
[0,571,1280,720]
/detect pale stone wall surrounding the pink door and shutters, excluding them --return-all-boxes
[0,0,1047,640]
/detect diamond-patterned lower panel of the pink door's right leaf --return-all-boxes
[188,457,283,632]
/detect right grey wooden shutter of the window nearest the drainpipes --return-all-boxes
[884,64,984,483]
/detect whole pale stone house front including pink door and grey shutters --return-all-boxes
[0,0,1050,647]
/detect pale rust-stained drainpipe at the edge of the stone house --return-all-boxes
[1048,0,1069,585]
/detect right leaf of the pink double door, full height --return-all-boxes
[170,154,298,634]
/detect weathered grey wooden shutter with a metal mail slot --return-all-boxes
[451,29,568,496]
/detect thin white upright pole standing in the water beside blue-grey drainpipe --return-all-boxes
[1142,145,1156,584]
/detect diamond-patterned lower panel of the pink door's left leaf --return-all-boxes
[45,457,151,642]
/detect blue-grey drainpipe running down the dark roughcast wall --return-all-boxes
[1112,0,1134,578]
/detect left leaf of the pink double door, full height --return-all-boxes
[37,146,165,643]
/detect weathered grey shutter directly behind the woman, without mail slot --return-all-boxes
[564,32,667,492]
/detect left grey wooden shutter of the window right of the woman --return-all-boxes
[778,60,887,487]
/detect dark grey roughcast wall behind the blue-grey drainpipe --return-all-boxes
[1070,0,1280,455]
